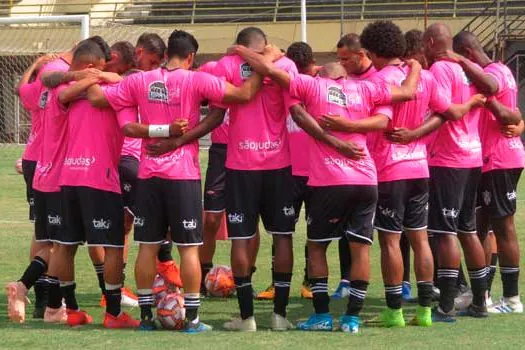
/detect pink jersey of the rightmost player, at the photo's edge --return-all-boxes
[479,62,525,172]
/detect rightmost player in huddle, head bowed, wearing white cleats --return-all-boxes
[452,32,525,313]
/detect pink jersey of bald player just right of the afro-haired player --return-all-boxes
[428,61,482,168]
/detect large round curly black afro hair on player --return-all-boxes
[361,21,407,58]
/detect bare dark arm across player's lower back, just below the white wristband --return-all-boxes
[146,107,226,156]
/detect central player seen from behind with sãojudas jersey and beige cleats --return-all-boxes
[211,27,297,331]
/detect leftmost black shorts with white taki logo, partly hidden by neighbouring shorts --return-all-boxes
[35,190,64,242]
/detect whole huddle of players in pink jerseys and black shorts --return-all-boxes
[7,21,525,333]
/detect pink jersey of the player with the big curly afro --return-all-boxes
[368,65,450,182]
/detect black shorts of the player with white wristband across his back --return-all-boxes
[134,177,202,246]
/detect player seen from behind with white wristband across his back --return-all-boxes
[88,30,261,333]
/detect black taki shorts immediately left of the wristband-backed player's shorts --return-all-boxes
[56,186,124,248]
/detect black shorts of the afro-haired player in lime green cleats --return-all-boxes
[374,179,428,233]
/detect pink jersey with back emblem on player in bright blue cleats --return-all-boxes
[290,74,391,186]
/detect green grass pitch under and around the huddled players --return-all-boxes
[0,147,525,350]
